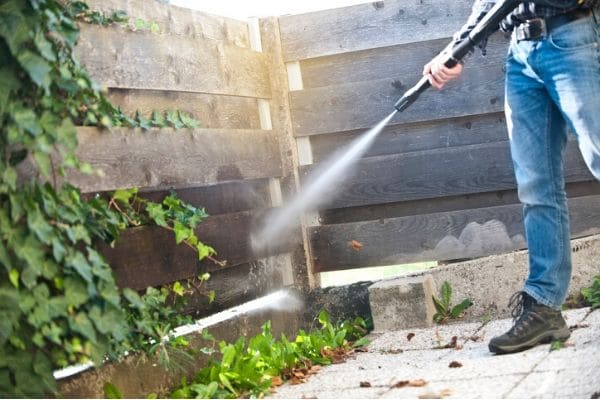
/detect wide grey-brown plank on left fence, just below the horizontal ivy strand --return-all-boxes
[68,128,281,192]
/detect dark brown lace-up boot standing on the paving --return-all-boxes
[488,292,571,354]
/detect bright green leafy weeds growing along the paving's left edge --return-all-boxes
[169,311,367,399]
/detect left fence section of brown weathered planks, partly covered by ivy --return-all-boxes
[69,0,306,314]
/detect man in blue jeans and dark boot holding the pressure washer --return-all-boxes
[423,0,600,353]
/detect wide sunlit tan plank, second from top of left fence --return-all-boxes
[76,25,271,98]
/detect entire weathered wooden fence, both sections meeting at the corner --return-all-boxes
[71,0,600,306]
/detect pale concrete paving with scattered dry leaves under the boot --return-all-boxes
[269,308,600,399]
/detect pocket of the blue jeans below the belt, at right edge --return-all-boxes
[548,17,600,50]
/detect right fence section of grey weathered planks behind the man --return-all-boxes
[279,0,600,272]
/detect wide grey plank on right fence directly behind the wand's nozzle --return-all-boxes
[290,63,504,136]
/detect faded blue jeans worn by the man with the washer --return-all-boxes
[505,10,600,308]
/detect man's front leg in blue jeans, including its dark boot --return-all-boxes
[489,36,571,353]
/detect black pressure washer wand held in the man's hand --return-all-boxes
[394,0,521,111]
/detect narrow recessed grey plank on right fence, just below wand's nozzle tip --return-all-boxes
[310,113,508,163]
